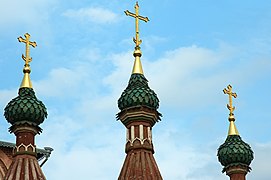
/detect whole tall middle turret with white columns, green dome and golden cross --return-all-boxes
[117,3,162,180]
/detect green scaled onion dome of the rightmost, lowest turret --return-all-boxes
[217,135,253,172]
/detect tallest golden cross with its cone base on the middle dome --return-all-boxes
[124,2,149,74]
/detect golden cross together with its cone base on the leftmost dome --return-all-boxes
[18,33,37,88]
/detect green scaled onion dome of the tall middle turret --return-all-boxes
[118,73,159,110]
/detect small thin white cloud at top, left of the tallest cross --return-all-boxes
[63,7,118,24]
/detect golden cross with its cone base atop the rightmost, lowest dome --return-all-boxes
[223,84,239,136]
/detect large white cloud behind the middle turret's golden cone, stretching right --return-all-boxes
[104,46,271,108]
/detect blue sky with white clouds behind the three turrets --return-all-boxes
[0,0,271,180]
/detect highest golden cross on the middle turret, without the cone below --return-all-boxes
[124,2,149,47]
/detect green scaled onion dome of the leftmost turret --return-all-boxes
[4,87,47,126]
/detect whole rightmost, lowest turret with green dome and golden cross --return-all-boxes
[217,85,253,180]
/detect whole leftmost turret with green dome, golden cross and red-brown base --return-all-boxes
[4,33,47,180]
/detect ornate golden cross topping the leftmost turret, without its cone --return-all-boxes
[18,33,37,66]
